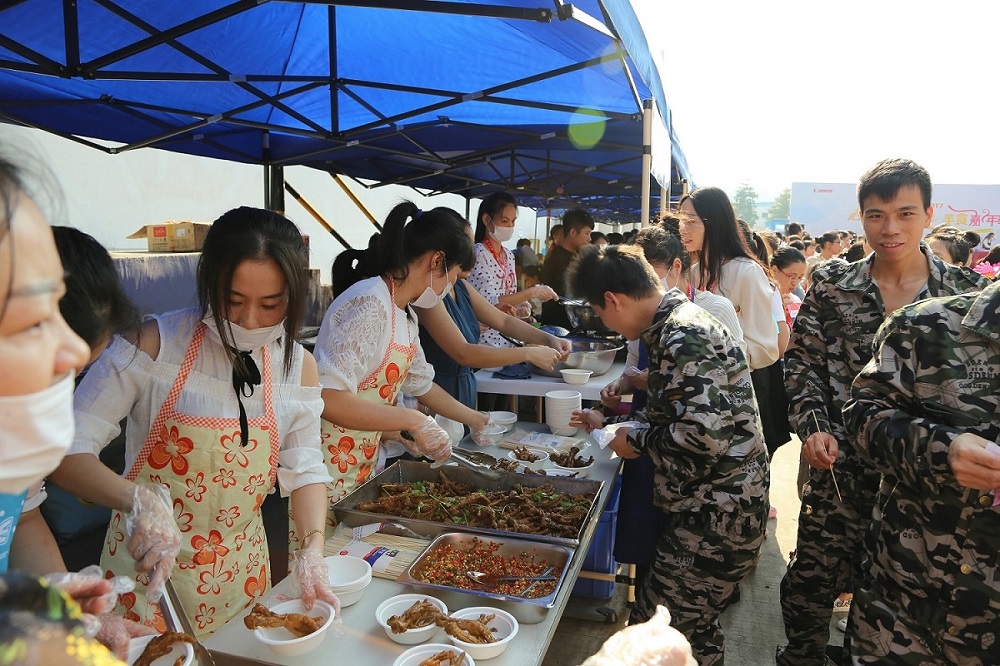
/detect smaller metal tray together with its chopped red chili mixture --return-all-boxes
[398,532,573,624]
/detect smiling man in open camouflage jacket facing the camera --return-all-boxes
[777,159,983,666]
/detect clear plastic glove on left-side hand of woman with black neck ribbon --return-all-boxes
[125,485,181,604]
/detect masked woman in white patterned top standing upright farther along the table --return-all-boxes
[468,192,559,347]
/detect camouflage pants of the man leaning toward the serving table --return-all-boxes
[629,503,768,666]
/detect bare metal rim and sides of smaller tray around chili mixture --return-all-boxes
[397,533,574,624]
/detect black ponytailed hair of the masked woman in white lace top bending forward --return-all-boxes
[331,201,476,298]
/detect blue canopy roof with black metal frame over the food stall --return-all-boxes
[0,0,689,207]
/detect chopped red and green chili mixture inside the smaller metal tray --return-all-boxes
[410,537,562,599]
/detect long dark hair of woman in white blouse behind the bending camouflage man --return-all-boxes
[680,187,766,291]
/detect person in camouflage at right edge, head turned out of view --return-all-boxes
[844,283,1000,666]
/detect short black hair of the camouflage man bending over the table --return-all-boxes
[568,245,660,308]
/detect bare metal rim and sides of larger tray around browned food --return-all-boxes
[333,460,604,547]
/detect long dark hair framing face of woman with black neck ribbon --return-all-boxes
[197,206,309,375]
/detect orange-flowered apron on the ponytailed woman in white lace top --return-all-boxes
[288,290,417,553]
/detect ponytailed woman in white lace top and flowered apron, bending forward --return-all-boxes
[308,201,489,540]
